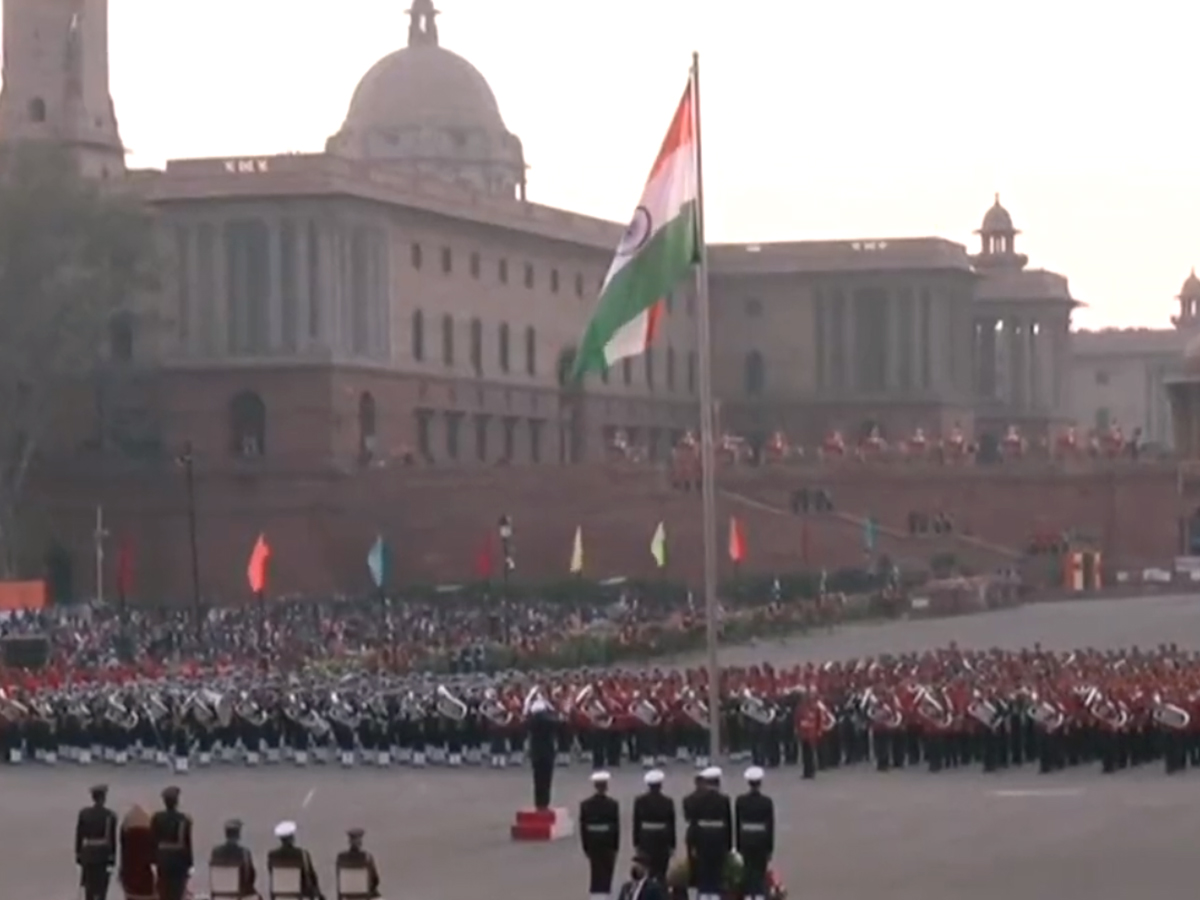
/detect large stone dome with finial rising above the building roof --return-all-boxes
[325,0,526,200]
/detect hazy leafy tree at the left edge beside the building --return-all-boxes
[0,144,156,576]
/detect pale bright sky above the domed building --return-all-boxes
[14,0,1200,326]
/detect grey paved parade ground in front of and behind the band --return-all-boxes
[11,598,1200,900]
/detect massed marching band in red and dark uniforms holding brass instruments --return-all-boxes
[7,646,1200,778]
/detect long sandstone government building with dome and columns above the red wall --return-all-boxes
[0,0,1200,474]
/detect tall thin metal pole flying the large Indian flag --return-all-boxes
[691,53,721,760]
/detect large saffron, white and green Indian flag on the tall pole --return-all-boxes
[575,80,700,379]
